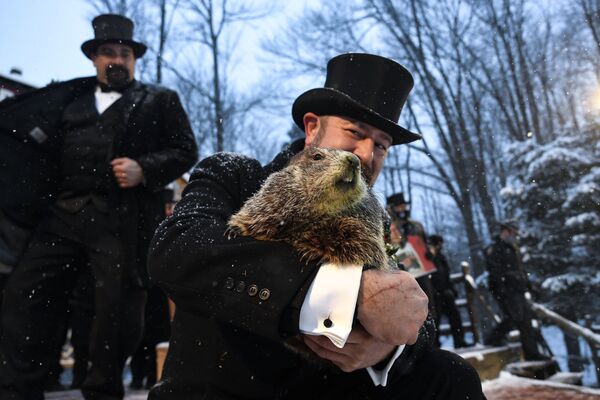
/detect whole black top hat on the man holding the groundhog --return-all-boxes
[292,53,421,145]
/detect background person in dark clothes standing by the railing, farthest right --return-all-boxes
[484,219,547,360]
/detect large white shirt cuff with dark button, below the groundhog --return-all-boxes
[299,264,362,348]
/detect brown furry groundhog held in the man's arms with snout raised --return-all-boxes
[228,147,392,270]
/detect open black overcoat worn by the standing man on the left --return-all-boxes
[0,77,197,280]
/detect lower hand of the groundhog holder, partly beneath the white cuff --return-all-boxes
[302,325,396,372]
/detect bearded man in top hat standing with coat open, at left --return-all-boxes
[0,14,197,400]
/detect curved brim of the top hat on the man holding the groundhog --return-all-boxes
[292,88,421,145]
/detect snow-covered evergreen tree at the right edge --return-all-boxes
[502,126,600,319]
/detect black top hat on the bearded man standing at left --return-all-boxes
[81,14,146,59]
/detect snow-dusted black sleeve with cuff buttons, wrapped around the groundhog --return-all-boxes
[148,154,316,340]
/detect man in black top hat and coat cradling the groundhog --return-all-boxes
[148,54,484,400]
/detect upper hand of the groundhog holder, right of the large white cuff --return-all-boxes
[357,269,428,345]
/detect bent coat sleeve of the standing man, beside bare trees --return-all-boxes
[136,90,198,188]
